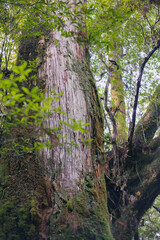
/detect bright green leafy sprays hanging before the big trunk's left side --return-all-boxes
[0,62,92,152]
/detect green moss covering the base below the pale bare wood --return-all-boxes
[51,179,113,240]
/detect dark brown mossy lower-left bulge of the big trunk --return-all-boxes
[0,133,50,240]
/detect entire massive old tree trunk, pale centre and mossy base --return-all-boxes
[0,1,112,240]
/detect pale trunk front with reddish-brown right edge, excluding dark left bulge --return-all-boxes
[38,21,112,239]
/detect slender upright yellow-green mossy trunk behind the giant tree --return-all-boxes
[108,47,127,144]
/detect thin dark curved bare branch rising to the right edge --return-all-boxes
[128,39,160,146]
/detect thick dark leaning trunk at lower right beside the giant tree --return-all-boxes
[106,145,160,240]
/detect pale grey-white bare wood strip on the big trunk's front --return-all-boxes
[38,29,92,192]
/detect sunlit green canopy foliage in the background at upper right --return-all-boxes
[87,1,160,135]
